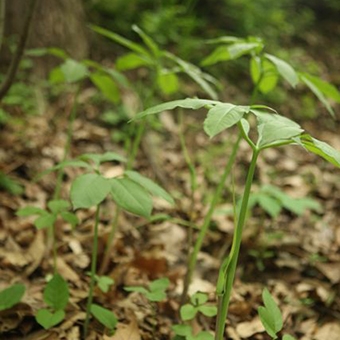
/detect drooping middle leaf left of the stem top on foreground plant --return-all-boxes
[204,103,249,138]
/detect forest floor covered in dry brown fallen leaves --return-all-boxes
[0,86,340,340]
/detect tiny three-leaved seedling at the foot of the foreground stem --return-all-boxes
[180,292,217,321]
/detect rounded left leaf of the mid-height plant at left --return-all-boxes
[71,174,110,209]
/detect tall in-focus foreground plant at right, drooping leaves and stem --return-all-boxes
[132,98,340,340]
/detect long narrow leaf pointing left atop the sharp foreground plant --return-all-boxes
[132,98,220,120]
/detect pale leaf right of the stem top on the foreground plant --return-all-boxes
[252,110,303,148]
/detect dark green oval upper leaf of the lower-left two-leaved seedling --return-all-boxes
[44,274,69,310]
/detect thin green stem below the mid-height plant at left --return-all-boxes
[84,204,100,339]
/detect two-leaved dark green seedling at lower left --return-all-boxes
[35,274,69,329]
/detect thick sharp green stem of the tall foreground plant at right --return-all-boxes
[215,148,260,340]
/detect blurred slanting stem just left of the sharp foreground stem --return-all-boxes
[181,134,242,302]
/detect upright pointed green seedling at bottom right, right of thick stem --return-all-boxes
[258,288,295,340]
